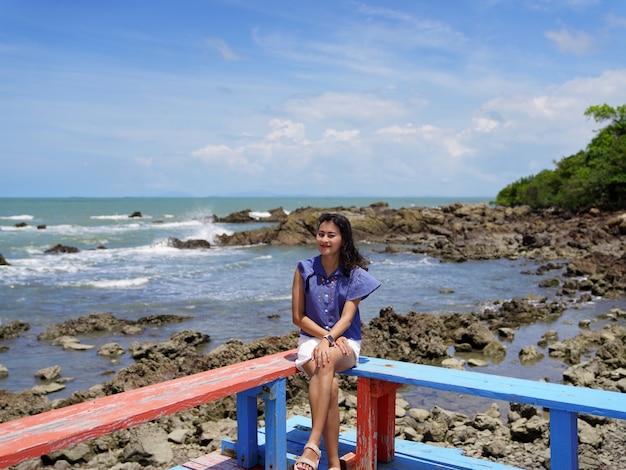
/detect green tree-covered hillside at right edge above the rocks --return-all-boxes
[495,104,626,211]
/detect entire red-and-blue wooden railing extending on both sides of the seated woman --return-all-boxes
[0,350,626,470]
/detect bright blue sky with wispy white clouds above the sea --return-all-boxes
[0,0,626,197]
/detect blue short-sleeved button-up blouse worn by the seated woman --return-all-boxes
[298,256,380,340]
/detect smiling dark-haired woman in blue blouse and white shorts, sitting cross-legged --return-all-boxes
[291,213,380,470]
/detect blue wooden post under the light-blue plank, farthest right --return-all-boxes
[550,409,578,470]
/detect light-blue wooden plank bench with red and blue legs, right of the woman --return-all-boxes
[344,357,626,470]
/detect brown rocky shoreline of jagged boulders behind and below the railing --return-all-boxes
[0,203,626,470]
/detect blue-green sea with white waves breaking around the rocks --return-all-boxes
[0,197,626,414]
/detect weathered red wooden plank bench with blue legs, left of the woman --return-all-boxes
[0,350,297,468]
